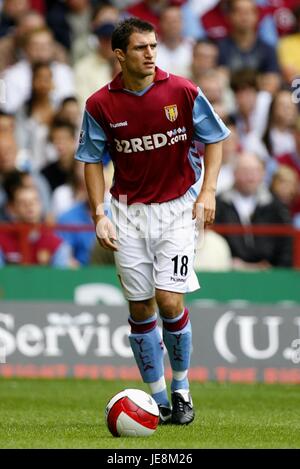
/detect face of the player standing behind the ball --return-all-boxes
[123,32,157,78]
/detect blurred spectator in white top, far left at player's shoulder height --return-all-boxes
[17,62,55,170]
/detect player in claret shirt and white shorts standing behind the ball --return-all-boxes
[76,18,229,424]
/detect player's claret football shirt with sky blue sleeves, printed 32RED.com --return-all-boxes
[75,68,230,204]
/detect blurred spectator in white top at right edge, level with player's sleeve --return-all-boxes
[263,90,298,158]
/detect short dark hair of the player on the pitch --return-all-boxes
[111,17,155,52]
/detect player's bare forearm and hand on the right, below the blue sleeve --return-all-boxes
[193,141,222,226]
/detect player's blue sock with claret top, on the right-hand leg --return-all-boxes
[162,308,192,392]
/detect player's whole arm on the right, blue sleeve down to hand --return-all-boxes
[193,88,230,226]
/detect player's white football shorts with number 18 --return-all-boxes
[111,192,200,301]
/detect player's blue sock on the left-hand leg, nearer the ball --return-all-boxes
[129,314,169,406]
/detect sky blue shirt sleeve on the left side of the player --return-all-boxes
[75,110,107,163]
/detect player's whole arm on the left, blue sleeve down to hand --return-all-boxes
[75,110,117,251]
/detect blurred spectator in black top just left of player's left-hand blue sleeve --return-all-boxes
[41,122,77,191]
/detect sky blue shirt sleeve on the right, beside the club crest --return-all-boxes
[193,88,230,144]
